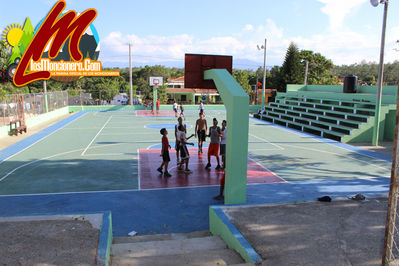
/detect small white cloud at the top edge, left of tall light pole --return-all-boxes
[317,0,368,30]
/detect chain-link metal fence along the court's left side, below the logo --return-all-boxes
[0,91,68,126]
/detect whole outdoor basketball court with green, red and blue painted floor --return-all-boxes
[0,106,391,235]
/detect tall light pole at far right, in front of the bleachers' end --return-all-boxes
[370,0,388,146]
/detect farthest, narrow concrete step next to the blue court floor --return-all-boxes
[112,231,211,244]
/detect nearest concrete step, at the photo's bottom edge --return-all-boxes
[111,249,245,266]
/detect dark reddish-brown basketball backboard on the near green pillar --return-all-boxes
[184,54,233,89]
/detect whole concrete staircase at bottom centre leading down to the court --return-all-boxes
[111,231,253,266]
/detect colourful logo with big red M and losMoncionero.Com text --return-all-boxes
[2,0,119,86]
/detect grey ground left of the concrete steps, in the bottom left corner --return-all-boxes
[0,220,99,265]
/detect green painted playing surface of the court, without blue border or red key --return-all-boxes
[0,109,391,195]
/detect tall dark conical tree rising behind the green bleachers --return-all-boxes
[281,42,303,87]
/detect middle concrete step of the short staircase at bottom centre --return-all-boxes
[111,236,227,258]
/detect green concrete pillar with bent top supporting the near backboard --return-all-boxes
[204,69,249,204]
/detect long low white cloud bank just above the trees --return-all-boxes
[100,16,399,68]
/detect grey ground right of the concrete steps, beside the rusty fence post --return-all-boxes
[227,198,398,266]
